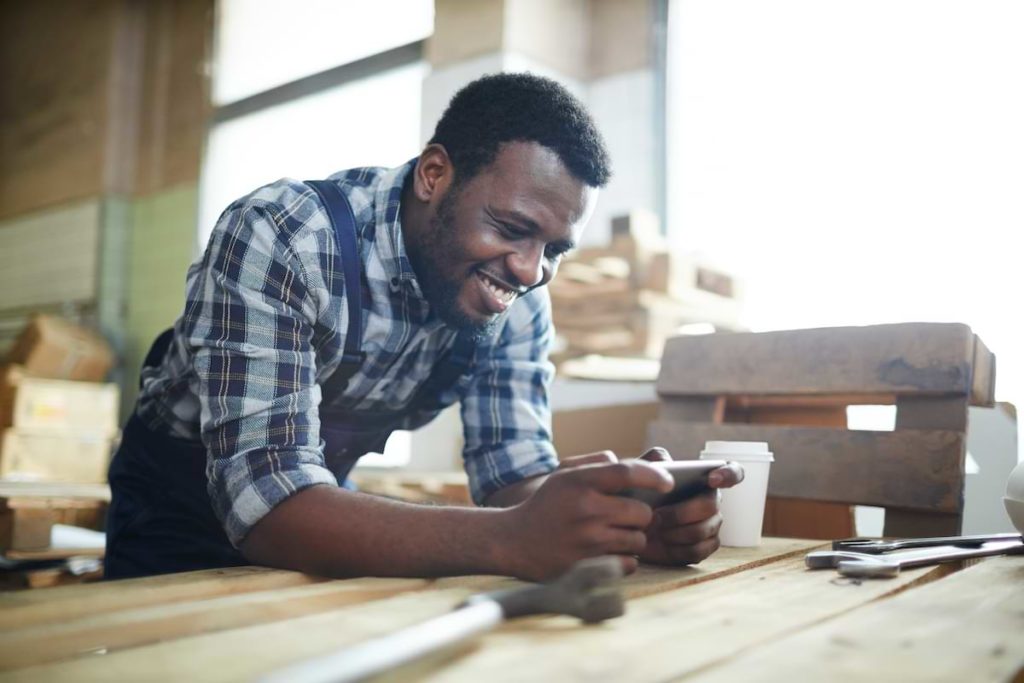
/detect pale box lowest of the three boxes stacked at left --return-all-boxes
[0,429,114,483]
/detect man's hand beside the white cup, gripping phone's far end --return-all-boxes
[640,449,743,564]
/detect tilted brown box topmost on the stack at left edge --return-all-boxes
[7,314,114,382]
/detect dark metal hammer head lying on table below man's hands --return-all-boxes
[471,556,626,624]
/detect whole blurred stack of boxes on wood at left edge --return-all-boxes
[0,315,119,586]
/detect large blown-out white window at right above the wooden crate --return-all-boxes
[668,0,1024,432]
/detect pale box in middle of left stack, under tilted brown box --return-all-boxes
[0,366,119,438]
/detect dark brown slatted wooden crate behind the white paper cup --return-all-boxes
[649,324,995,538]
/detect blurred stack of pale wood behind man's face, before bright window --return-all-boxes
[550,211,741,362]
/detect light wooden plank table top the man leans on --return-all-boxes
[0,539,1024,683]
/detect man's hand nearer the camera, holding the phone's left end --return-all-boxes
[499,454,673,580]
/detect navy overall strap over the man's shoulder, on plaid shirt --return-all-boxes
[305,180,364,402]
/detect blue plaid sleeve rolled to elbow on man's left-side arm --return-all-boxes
[181,194,337,547]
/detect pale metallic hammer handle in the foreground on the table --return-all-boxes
[262,600,504,683]
